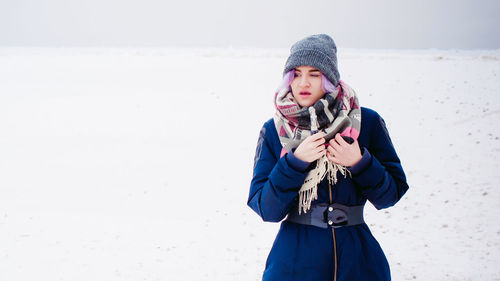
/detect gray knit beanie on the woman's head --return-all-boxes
[283,34,340,86]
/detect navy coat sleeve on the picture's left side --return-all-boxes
[247,122,307,222]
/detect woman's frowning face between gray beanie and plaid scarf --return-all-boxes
[290,65,325,107]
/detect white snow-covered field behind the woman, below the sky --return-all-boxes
[0,48,500,281]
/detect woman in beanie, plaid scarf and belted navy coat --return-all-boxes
[248,34,408,281]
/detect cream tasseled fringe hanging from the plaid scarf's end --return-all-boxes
[299,155,351,215]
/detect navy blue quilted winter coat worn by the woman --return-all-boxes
[248,108,408,281]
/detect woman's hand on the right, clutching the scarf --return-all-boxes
[326,134,361,167]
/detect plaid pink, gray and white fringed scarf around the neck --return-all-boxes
[274,81,361,214]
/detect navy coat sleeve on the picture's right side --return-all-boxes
[352,112,408,210]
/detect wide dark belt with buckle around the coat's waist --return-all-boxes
[285,203,365,228]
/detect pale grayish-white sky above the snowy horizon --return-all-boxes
[0,0,500,49]
